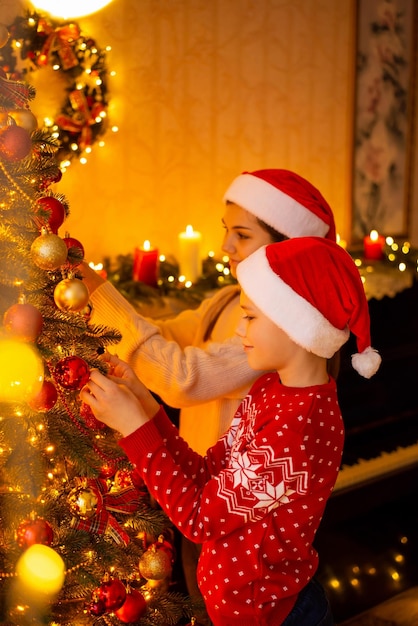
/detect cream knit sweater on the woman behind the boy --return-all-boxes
[91,283,261,454]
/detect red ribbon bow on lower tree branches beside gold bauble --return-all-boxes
[71,478,141,545]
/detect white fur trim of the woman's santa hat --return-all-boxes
[224,174,329,238]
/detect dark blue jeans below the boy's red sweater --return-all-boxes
[282,579,334,626]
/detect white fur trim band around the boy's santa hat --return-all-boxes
[237,244,350,359]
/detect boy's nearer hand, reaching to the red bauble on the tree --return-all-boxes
[80,370,159,437]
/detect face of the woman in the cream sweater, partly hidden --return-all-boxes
[222,204,272,278]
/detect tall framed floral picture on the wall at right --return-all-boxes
[352,0,417,242]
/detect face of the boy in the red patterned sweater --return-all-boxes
[236,292,301,372]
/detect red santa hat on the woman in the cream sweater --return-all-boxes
[224,169,336,241]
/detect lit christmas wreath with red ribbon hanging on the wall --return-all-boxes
[0,13,108,162]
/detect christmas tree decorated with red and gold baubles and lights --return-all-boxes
[0,27,195,626]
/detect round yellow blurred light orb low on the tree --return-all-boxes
[16,543,65,596]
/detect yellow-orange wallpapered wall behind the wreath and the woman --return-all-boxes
[4,0,354,261]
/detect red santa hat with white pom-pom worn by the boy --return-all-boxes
[237,237,381,378]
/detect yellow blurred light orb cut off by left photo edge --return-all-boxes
[0,339,44,402]
